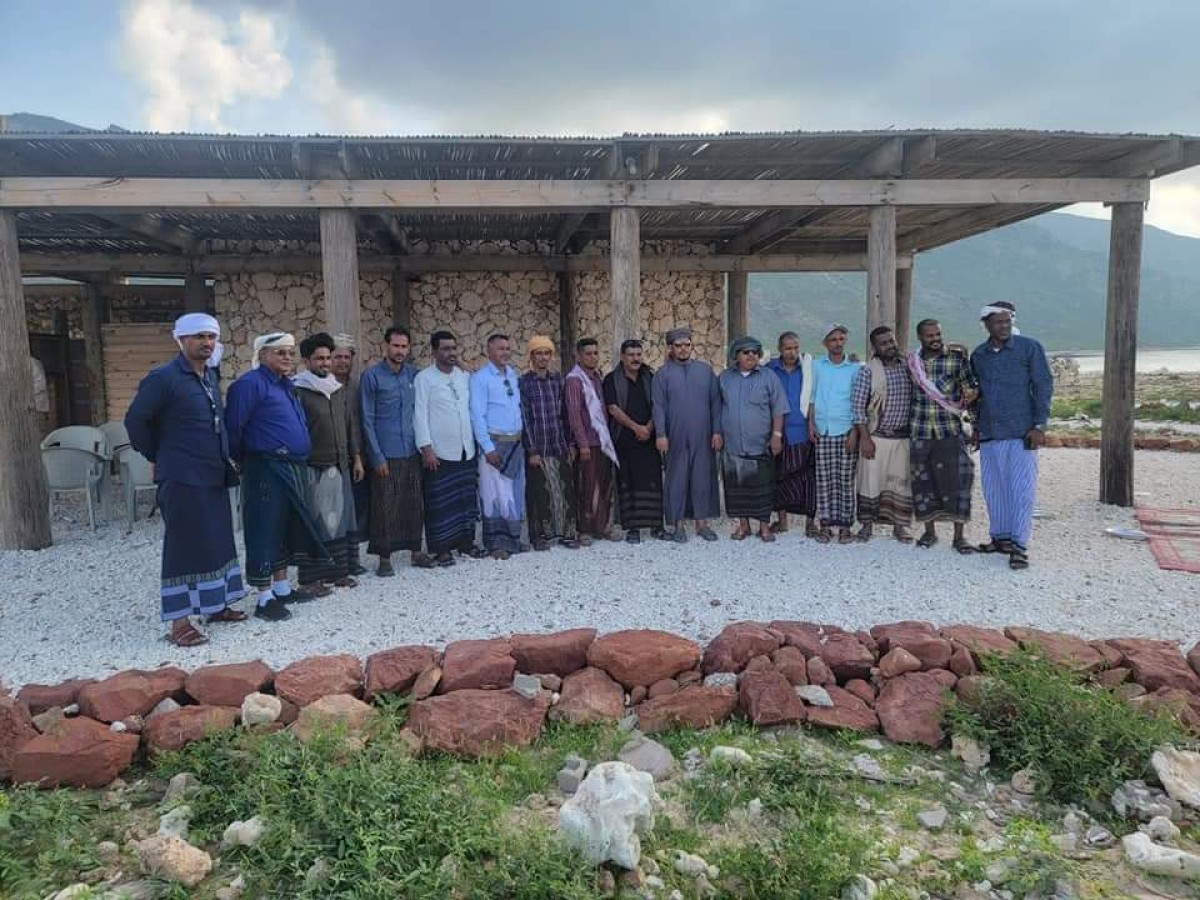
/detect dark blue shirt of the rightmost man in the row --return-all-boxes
[971,335,1054,440]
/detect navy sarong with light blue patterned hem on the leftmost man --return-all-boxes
[158,481,246,622]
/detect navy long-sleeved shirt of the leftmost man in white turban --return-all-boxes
[125,355,229,487]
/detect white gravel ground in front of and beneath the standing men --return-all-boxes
[0,450,1200,686]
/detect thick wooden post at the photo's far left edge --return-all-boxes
[0,210,50,550]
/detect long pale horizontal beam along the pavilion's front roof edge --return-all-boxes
[0,178,1150,212]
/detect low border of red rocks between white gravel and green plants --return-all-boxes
[0,620,1200,787]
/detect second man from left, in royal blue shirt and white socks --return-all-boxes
[226,331,332,622]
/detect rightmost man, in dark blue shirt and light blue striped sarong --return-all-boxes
[971,304,1054,569]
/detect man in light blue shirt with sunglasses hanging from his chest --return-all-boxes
[470,334,524,559]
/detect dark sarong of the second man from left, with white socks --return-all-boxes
[241,456,332,588]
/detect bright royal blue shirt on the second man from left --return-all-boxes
[226,366,312,462]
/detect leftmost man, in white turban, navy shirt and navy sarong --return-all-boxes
[125,313,246,647]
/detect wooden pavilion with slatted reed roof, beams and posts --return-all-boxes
[0,130,1200,548]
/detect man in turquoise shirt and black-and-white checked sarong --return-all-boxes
[809,323,862,544]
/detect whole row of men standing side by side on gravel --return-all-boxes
[126,305,1051,647]
